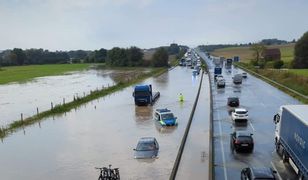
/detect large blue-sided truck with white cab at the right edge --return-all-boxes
[274,105,308,179]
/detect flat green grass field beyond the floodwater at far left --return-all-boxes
[0,64,90,84]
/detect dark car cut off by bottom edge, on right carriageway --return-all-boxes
[241,167,278,180]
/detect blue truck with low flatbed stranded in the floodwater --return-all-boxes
[133,84,160,106]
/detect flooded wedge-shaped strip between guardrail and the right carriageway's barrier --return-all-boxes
[176,74,212,180]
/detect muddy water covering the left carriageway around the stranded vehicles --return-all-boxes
[0,67,199,180]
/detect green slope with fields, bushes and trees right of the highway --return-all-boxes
[212,32,308,103]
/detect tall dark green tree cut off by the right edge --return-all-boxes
[292,31,308,68]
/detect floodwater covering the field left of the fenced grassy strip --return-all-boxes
[0,69,144,126]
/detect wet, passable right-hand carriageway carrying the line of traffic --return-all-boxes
[199,51,300,180]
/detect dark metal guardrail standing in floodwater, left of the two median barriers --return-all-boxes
[169,71,204,180]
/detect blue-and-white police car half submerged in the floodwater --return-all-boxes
[154,108,177,126]
